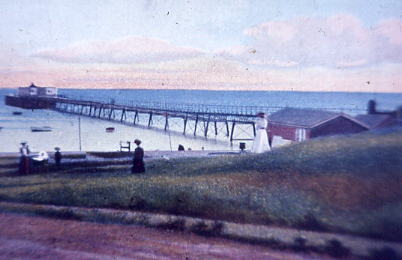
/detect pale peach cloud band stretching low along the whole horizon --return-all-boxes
[0,58,402,93]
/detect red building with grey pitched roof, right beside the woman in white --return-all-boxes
[268,108,369,142]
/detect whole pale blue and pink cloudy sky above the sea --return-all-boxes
[0,0,402,93]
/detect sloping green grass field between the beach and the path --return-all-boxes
[0,130,402,241]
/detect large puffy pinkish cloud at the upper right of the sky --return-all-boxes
[217,14,402,68]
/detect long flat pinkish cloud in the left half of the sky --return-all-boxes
[32,37,203,64]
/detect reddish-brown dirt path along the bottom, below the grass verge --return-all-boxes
[0,213,330,260]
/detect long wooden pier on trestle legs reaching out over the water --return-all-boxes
[6,96,278,142]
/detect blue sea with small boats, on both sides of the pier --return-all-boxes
[0,88,402,152]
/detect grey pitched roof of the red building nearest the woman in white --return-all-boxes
[269,108,369,129]
